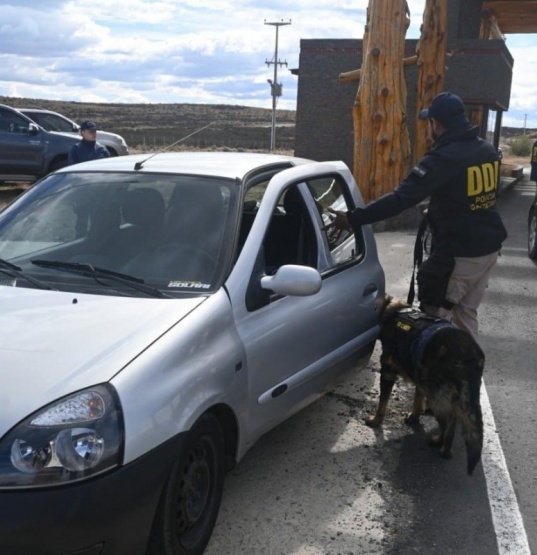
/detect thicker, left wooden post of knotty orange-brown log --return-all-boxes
[353,0,410,203]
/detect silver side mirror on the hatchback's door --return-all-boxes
[261,264,323,297]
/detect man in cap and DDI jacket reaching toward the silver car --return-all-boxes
[326,92,507,337]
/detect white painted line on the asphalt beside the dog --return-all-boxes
[481,382,531,555]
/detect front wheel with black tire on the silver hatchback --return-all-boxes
[146,414,225,555]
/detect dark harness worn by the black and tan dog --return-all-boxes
[394,307,453,378]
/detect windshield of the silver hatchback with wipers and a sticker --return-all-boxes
[0,172,238,298]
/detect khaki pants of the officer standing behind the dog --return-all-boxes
[424,252,499,339]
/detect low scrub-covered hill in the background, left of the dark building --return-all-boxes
[0,96,295,151]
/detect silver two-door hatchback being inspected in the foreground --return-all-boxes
[0,152,384,555]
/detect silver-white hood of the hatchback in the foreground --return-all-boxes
[0,286,205,437]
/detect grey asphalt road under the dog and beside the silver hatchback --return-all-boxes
[206,172,537,555]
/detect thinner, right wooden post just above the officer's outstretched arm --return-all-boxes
[412,0,448,162]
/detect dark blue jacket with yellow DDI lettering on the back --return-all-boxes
[348,124,507,258]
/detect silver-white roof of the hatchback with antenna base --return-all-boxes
[60,151,312,179]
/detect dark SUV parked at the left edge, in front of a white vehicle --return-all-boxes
[0,104,80,181]
